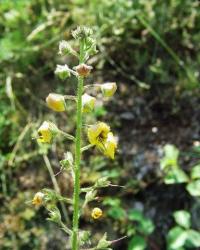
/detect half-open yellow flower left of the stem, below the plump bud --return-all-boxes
[37,121,58,143]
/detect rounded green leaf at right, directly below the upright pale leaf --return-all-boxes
[164,168,189,184]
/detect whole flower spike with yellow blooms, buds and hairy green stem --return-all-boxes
[32,27,117,250]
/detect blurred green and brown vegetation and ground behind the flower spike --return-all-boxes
[0,0,200,250]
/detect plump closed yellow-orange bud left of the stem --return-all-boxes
[46,93,65,112]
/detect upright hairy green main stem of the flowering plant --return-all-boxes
[72,40,84,250]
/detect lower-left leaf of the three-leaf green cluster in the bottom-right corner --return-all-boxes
[167,227,187,250]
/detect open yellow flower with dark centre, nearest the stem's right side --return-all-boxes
[87,122,110,150]
